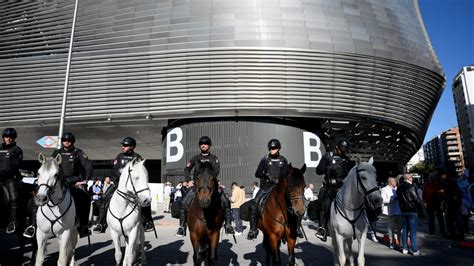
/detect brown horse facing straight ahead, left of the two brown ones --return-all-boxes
[187,163,223,265]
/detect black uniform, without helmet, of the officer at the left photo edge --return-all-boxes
[0,142,23,233]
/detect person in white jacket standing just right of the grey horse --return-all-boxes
[380,177,402,249]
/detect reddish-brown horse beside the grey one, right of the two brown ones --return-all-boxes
[258,164,306,265]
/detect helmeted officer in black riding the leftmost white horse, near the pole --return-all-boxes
[51,132,92,237]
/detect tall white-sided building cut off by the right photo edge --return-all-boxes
[452,66,474,168]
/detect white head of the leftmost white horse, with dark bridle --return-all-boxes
[35,153,62,206]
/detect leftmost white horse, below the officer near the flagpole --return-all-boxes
[35,153,78,266]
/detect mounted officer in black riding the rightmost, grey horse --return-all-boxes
[316,139,354,242]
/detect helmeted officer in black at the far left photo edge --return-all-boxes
[0,128,23,234]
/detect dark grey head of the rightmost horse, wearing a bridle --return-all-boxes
[354,158,382,209]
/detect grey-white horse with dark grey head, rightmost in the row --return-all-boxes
[329,158,382,266]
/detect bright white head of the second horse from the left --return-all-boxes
[118,158,151,207]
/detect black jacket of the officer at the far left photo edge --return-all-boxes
[0,142,23,181]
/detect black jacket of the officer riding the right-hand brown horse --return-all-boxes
[255,154,288,190]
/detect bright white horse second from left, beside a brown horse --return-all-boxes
[107,159,151,265]
